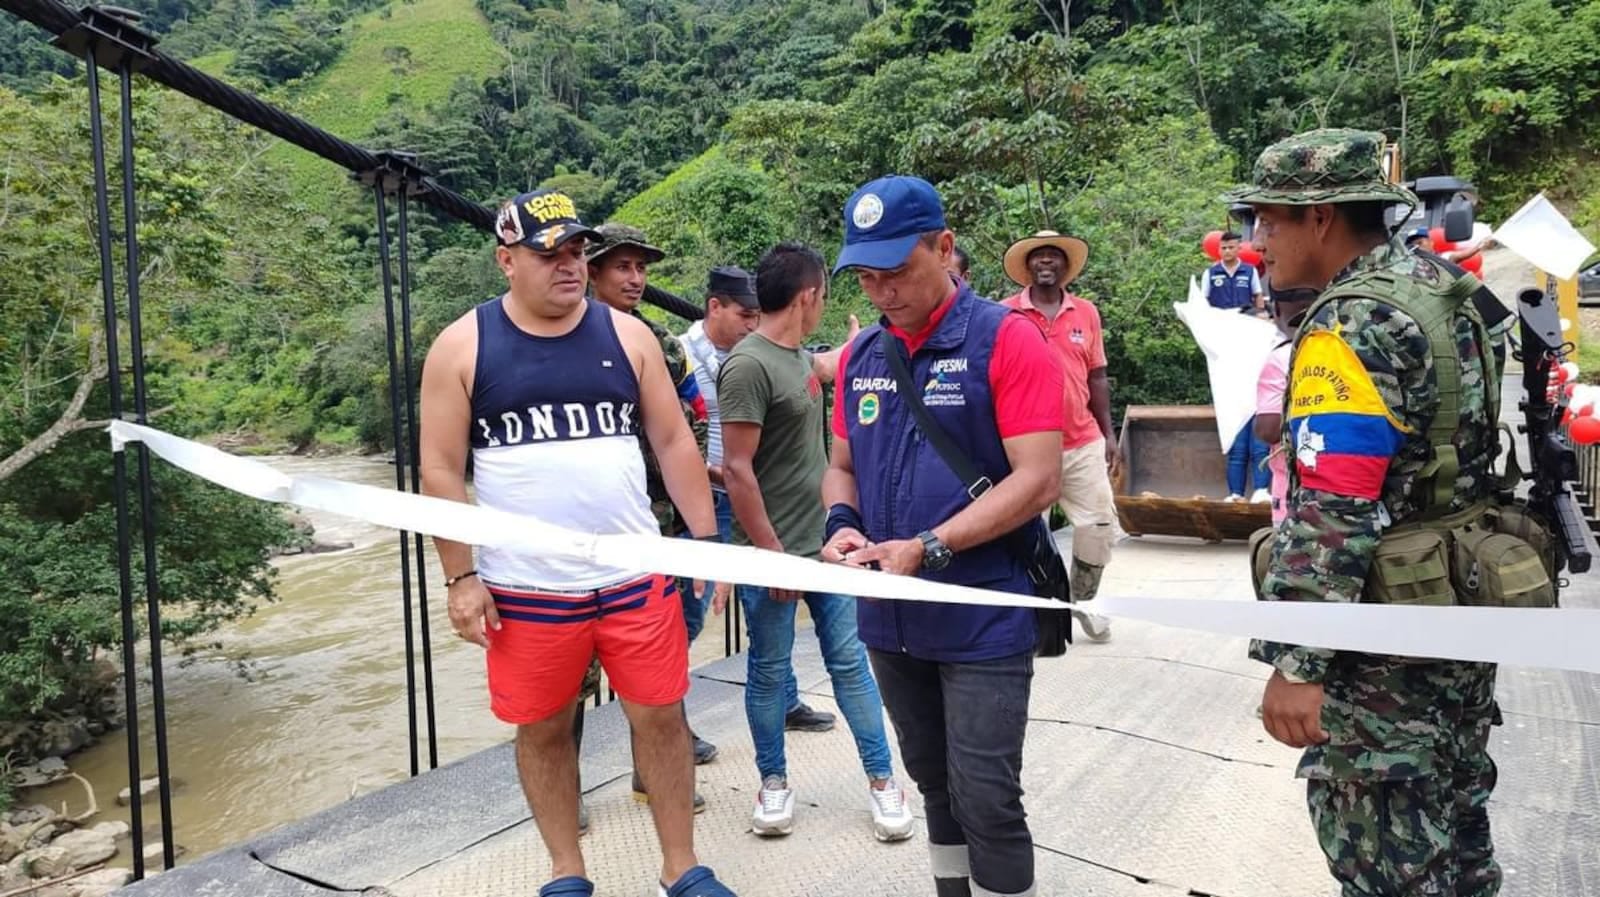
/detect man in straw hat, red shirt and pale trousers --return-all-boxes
[1000,230,1117,641]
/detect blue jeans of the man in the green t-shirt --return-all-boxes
[738,585,894,779]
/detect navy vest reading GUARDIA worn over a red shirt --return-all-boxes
[840,286,1037,662]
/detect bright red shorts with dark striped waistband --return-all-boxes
[488,574,690,726]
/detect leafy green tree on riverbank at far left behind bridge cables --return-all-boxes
[0,82,293,738]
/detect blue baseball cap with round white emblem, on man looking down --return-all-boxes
[834,174,944,273]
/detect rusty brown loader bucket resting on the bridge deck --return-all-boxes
[1112,405,1272,542]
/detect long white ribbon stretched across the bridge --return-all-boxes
[110,421,1600,673]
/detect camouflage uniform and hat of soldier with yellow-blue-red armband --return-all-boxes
[1227,131,1501,897]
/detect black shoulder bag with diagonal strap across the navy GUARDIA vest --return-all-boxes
[880,333,1072,657]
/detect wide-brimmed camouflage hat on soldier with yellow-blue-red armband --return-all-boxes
[1222,128,1418,208]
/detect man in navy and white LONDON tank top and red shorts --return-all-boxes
[421,190,733,897]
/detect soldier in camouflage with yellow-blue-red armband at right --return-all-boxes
[1226,130,1501,897]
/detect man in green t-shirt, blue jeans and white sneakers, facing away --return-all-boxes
[717,243,914,841]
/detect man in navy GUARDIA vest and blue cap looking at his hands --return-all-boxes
[822,176,1066,897]
